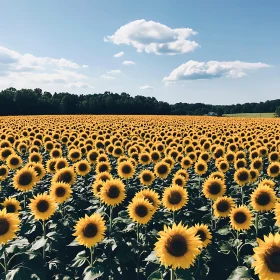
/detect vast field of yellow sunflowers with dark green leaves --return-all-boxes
[0,115,280,280]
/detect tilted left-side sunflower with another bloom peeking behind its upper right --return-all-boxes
[13,167,38,192]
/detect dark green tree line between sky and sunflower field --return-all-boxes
[0,88,280,116]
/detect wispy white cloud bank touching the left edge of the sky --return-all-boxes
[0,46,88,88]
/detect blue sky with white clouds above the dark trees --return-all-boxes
[0,0,280,104]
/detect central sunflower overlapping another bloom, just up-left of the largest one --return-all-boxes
[127,197,154,224]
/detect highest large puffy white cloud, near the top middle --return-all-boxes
[104,19,199,55]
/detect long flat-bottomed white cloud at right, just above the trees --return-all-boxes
[163,60,269,83]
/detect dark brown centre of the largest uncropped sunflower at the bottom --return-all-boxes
[165,234,188,257]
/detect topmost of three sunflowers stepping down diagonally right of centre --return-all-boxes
[202,178,226,200]
